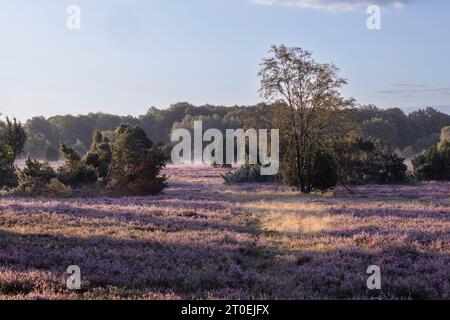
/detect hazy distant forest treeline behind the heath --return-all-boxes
[0,102,450,161]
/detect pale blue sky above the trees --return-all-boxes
[0,0,450,120]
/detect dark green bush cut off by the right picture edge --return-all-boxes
[412,140,450,180]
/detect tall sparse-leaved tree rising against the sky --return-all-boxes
[259,45,353,193]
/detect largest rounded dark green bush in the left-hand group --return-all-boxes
[108,125,166,195]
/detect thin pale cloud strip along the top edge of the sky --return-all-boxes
[251,0,410,11]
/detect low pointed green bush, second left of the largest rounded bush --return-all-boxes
[58,144,98,188]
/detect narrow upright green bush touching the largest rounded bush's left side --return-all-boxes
[84,130,112,179]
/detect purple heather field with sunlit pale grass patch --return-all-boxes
[0,167,450,299]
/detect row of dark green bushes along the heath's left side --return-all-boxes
[0,120,166,197]
